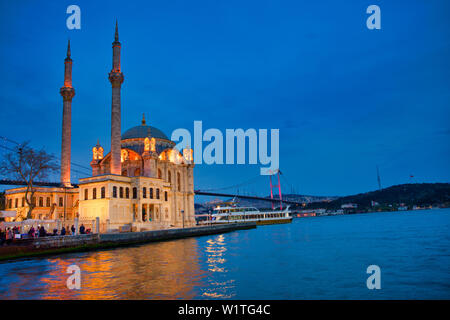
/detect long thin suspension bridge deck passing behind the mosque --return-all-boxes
[0,179,302,206]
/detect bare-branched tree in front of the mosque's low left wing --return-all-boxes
[0,142,59,219]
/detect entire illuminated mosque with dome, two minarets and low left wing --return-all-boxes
[2,22,195,231]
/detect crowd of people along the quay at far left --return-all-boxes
[0,224,91,245]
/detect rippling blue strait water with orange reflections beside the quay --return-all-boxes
[0,209,450,299]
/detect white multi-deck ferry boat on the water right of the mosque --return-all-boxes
[204,206,292,225]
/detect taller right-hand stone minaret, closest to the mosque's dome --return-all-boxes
[109,20,123,175]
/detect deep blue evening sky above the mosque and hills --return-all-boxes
[0,0,450,196]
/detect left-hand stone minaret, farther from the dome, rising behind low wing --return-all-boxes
[59,40,75,187]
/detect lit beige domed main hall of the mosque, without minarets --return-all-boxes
[79,120,195,230]
